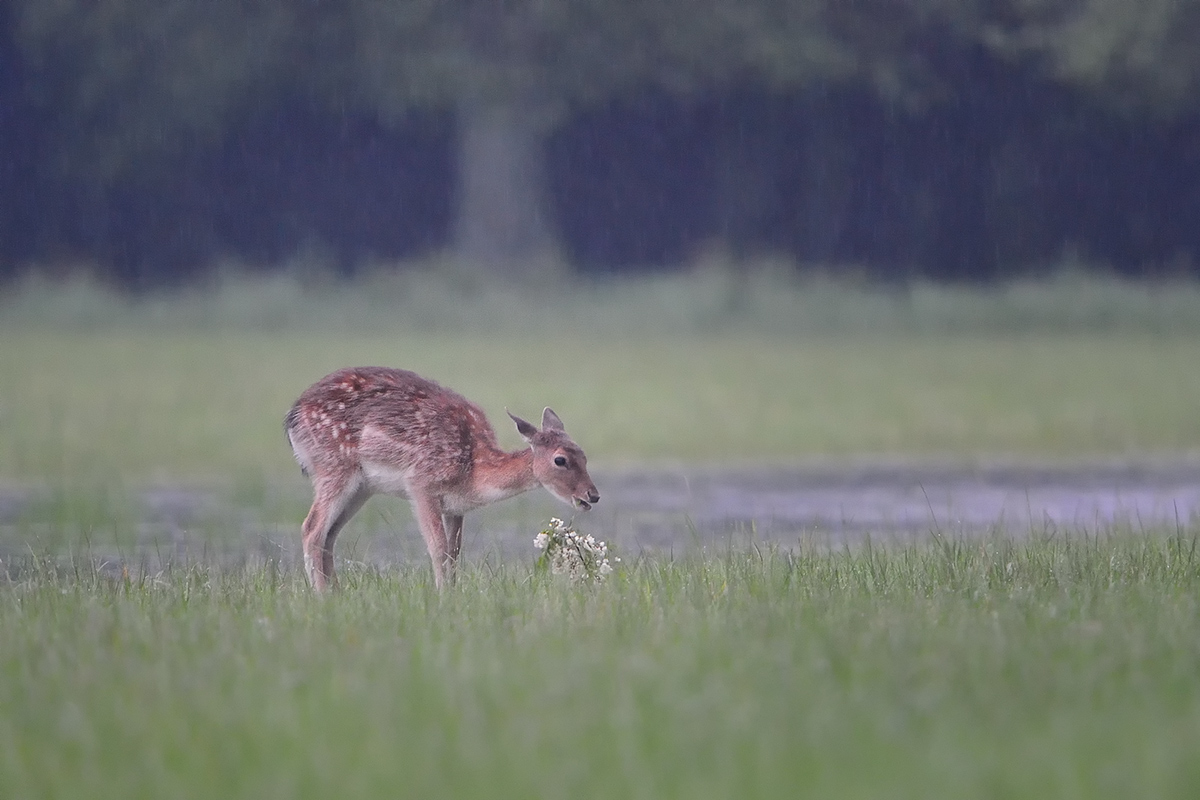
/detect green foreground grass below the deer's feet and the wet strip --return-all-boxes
[0,530,1200,799]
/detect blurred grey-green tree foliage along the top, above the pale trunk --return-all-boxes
[11,0,1200,174]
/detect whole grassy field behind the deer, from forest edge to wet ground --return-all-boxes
[0,271,1200,486]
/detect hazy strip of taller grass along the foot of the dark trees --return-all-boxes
[7,266,1200,339]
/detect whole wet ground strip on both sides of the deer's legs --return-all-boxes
[0,459,1200,566]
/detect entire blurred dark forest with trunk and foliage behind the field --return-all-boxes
[0,0,1200,290]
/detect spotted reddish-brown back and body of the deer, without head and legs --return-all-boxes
[286,367,496,486]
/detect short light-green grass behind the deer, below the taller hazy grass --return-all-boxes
[0,284,1200,486]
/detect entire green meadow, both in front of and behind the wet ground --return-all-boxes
[0,271,1200,798]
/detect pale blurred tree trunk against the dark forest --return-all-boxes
[455,98,558,279]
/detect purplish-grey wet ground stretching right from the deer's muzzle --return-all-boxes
[608,462,1200,551]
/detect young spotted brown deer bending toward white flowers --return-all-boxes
[283,367,600,594]
